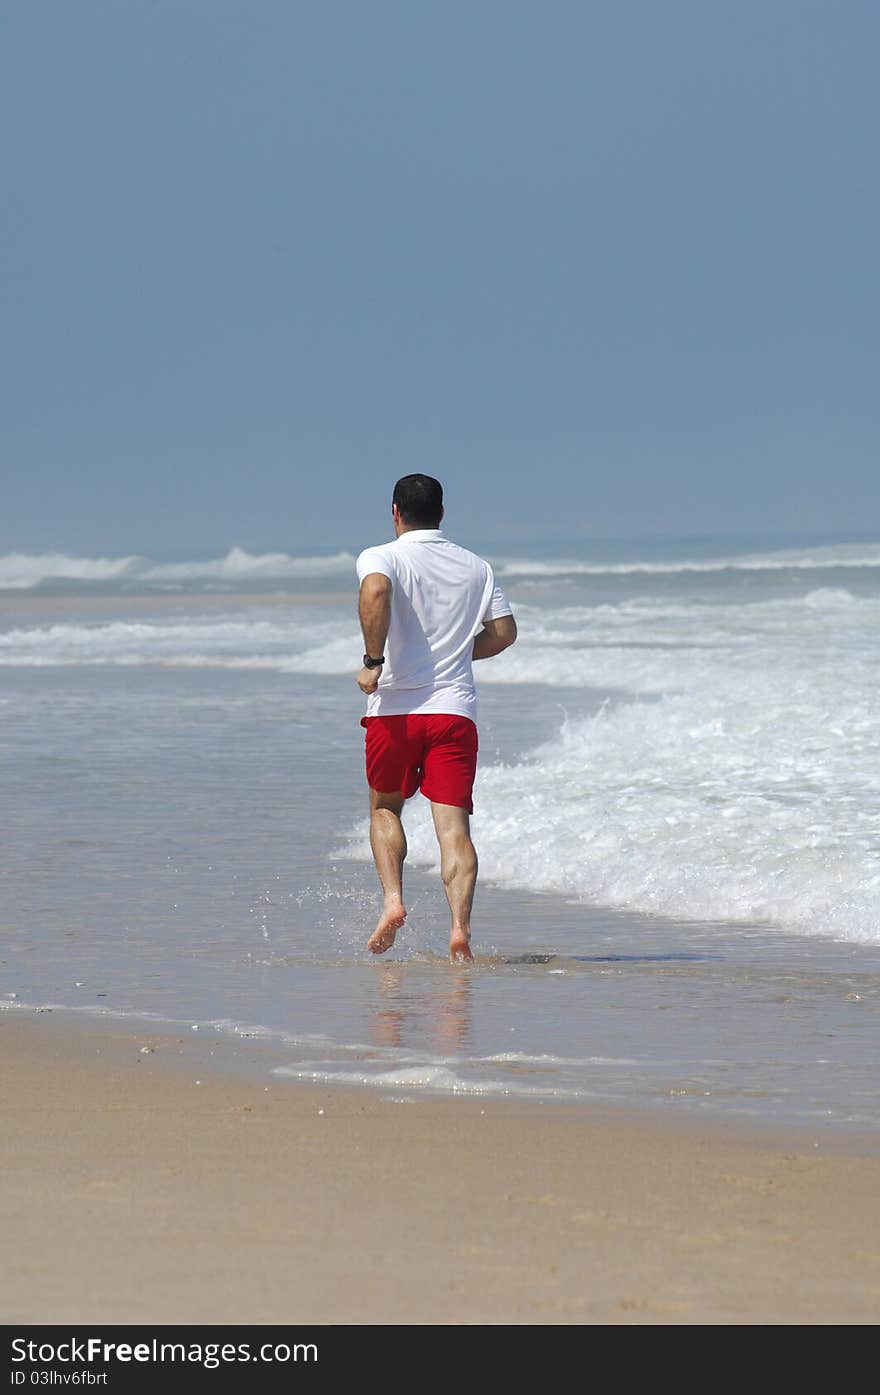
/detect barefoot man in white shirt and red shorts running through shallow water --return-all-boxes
[357,474,516,963]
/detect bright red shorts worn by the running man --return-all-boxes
[361,711,477,813]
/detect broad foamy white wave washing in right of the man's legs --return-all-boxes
[340,667,880,943]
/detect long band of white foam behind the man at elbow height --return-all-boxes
[0,589,880,680]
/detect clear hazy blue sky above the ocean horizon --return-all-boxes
[0,0,880,555]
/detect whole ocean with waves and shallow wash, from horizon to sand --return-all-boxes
[0,538,880,1133]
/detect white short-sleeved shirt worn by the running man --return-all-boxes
[357,527,512,721]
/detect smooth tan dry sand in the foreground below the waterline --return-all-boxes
[0,1010,880,1324]
